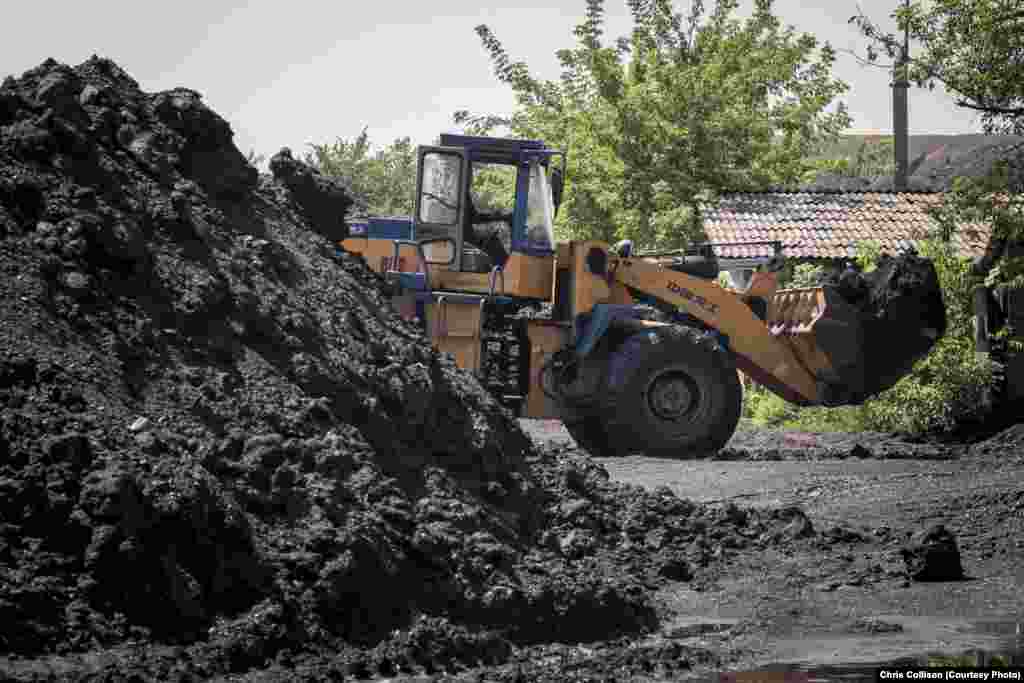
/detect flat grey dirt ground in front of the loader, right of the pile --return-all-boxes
[524,421,1024,680]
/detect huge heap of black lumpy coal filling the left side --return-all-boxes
[0,57,790,680]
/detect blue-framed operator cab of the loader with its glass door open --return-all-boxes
[413,134,564,272]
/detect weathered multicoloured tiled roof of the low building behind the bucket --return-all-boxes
[703,191,989,259]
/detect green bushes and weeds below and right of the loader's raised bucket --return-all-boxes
[744,239,991,433]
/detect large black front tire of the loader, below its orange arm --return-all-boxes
[602,326,742,459]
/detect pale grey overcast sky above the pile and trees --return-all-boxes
[0,0,980,156]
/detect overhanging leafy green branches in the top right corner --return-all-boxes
[850,0,1024,133]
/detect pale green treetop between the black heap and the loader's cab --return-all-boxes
[305,128,416,216]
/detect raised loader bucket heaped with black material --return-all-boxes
[769,255,946,405]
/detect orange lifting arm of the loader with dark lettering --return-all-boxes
[608,255,820,405]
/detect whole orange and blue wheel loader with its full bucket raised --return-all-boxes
[341,134,945,458]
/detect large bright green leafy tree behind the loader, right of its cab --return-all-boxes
[456,0,849,247]
